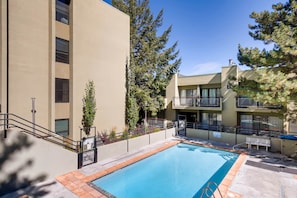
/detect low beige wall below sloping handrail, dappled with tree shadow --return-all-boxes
[0,129,78,193]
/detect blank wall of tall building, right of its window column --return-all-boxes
[70,0,130,139]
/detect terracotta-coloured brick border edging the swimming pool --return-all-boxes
[56,141,246,198]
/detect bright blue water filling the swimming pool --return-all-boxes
[92,144,238,198]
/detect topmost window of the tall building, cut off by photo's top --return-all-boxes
[56,0,70,24]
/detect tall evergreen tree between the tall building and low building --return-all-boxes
[112,0,181,127]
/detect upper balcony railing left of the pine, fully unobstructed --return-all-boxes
[173,97,221,107]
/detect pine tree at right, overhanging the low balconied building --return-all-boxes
[231,0,297,120]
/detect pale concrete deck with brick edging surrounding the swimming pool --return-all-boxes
[3,139,297,198]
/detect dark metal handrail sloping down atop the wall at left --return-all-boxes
[0,113,80,152]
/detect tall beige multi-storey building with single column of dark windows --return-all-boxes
[0,0,130,140]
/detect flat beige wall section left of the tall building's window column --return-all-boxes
[7,0,52,127]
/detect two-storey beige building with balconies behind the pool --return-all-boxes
[166,64,297,136]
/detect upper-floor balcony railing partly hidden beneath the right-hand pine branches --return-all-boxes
[236,97,281,109]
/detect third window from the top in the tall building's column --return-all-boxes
[55,78,69,103]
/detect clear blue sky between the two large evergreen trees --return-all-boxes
[105,0,286,75]
